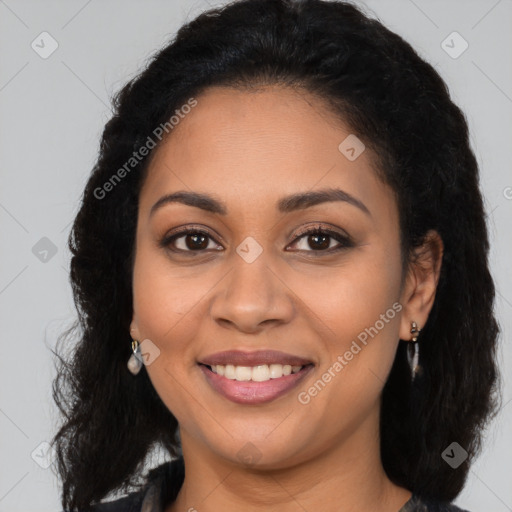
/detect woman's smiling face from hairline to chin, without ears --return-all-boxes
[132,87,421,468]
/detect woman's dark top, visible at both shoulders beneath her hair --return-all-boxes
[82,457,468,512]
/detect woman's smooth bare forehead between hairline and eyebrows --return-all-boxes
[141,86,392,220]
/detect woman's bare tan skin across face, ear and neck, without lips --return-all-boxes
[131,86,442,512]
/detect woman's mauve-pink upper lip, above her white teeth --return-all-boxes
[199,350,312,366]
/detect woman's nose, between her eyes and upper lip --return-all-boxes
[210,251,295,333]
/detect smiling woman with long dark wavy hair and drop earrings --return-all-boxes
[54,0,499,512]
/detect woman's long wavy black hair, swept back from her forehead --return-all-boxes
[53,0,499,511]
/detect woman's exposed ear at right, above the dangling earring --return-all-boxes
[400,230,444,341]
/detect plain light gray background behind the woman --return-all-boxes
[0,0,512,512]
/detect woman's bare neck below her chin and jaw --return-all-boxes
[165,408,411,512]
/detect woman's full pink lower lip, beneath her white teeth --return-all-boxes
[199,364,313,404]
